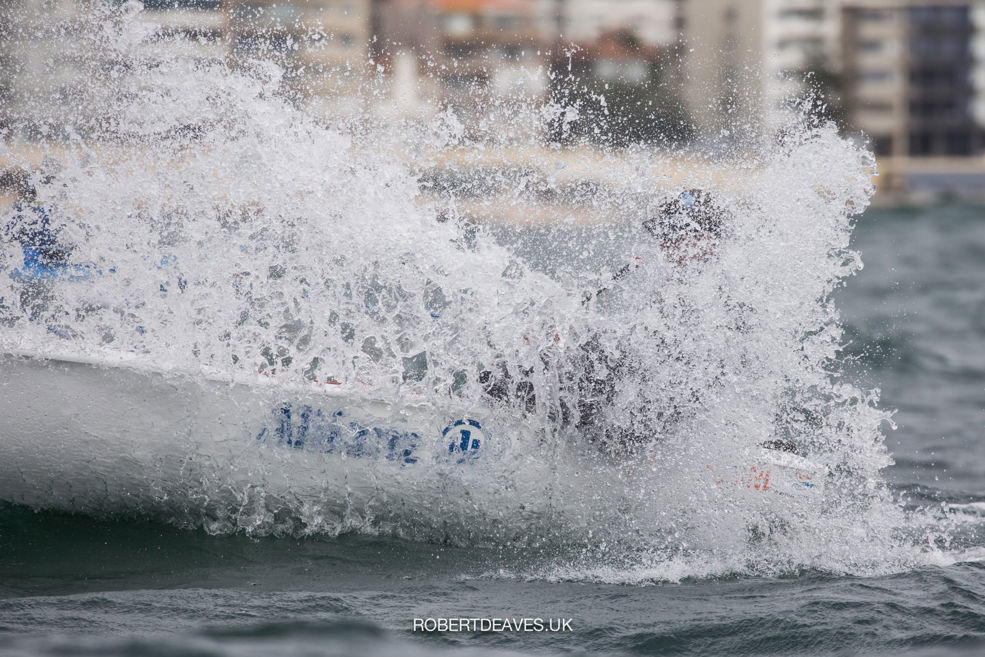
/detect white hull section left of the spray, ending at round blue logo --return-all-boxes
[0,355,503,510]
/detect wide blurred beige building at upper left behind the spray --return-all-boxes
[0,0,371,139]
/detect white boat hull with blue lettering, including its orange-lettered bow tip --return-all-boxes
[0,348,823,531]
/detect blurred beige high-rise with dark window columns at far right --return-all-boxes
[841,0,985,156]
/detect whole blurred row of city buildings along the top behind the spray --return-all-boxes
[0,0,985,201]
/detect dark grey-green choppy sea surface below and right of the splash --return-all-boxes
[0,203,985,655]
